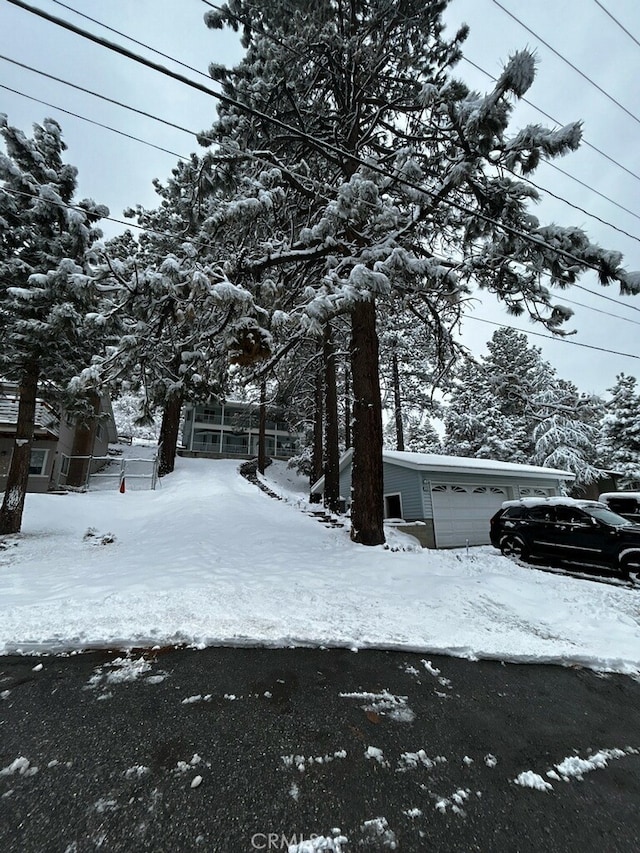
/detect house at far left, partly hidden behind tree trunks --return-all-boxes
[0,382,117,493]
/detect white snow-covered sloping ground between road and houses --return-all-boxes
[0,448,640,674]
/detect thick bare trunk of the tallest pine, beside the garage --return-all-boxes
[351,299,385,545]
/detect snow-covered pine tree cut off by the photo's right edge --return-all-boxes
[599,373,640,487]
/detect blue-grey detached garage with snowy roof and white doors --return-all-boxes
[311,449,574,548]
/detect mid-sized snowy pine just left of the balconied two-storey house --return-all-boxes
[97,155,270,476]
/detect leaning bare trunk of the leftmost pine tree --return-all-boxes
[0,362,39,534]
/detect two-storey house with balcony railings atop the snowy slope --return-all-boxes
[178,400,302,459]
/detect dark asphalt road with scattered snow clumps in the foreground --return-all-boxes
[0,644,640,853]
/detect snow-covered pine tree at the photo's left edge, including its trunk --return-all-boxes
[0,114,109,533]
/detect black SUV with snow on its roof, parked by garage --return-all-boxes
[491,497,640,578]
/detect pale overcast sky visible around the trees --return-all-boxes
[0,0,640,394]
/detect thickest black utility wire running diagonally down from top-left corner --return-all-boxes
[7,0,636,288]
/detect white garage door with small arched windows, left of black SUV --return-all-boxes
[431,483,509,548]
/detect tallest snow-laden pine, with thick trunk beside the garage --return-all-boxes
[200,0,638,545]
